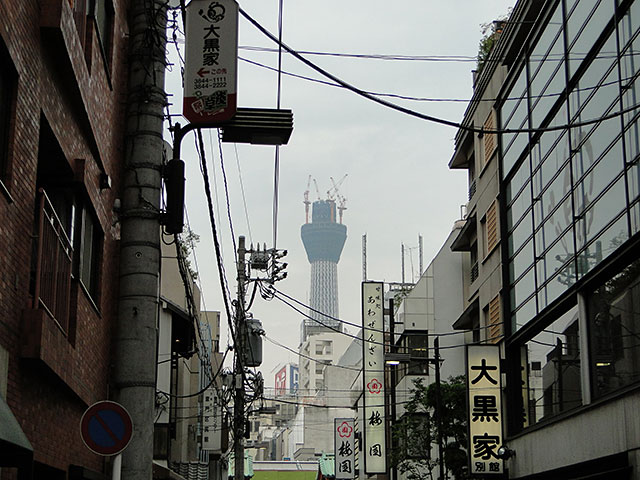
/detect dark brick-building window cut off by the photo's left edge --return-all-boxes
[0,40,17,186]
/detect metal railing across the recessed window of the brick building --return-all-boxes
[33,189,73,333]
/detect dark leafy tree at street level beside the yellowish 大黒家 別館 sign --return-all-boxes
[391,375,467,480]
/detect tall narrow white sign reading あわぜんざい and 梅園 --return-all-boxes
[362,282,387,474]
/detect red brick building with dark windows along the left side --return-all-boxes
[0,0,128,480]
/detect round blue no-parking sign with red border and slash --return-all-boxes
[80,400,133,455]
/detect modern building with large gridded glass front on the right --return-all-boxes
[452,0,640,479]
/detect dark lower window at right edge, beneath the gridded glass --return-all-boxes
[587,260,640,397]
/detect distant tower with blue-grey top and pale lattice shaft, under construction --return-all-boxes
[301,196,347,342]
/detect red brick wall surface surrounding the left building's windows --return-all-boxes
[0,0,128,479]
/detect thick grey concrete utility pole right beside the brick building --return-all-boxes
[113,0,167,480]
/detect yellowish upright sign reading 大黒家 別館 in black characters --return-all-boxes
[467,345,503,475]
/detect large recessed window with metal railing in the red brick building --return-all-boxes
[31,117,103,339]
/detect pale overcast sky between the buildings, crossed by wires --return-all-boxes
[167,0,515,386]
